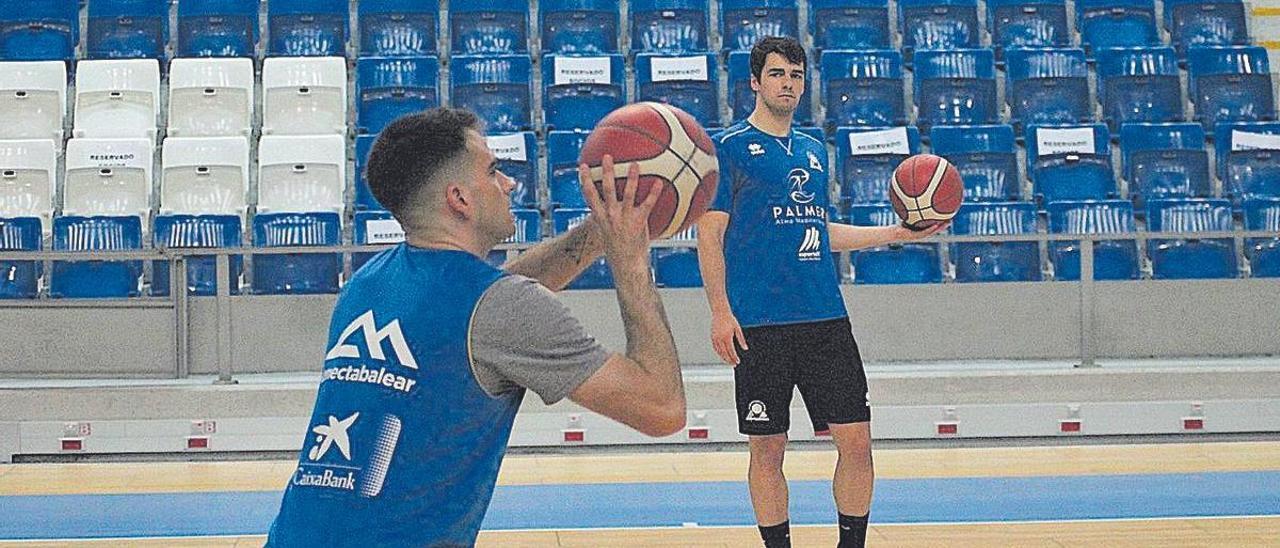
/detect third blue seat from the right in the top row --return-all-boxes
[987,0,1071,59]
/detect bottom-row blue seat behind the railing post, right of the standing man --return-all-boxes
[1047,200,1140,280]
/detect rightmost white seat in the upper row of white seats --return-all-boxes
[262,58,347,134]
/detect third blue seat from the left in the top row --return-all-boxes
[177,0,259,58]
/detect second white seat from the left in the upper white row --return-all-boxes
[74,59,160,140]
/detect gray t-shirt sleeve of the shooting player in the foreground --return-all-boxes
[468,275,609,405]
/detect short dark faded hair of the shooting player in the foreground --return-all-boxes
[365,106,484,223]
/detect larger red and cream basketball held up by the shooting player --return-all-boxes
[579,102,719,239]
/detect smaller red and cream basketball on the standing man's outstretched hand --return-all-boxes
[888,154,964,230]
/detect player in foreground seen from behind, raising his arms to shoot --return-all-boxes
[268,109,685,547]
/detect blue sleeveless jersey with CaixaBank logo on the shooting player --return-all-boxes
[268,245,525,547]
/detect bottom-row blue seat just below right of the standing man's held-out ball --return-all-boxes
[951,202,1041,282]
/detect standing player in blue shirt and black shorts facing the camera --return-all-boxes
[698,37,946,548]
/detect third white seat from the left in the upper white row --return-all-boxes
[168,58,255,137]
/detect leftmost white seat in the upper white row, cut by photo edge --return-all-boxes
[0,61,67,144]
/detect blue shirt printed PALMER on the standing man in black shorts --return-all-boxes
[710,120,847,326]
